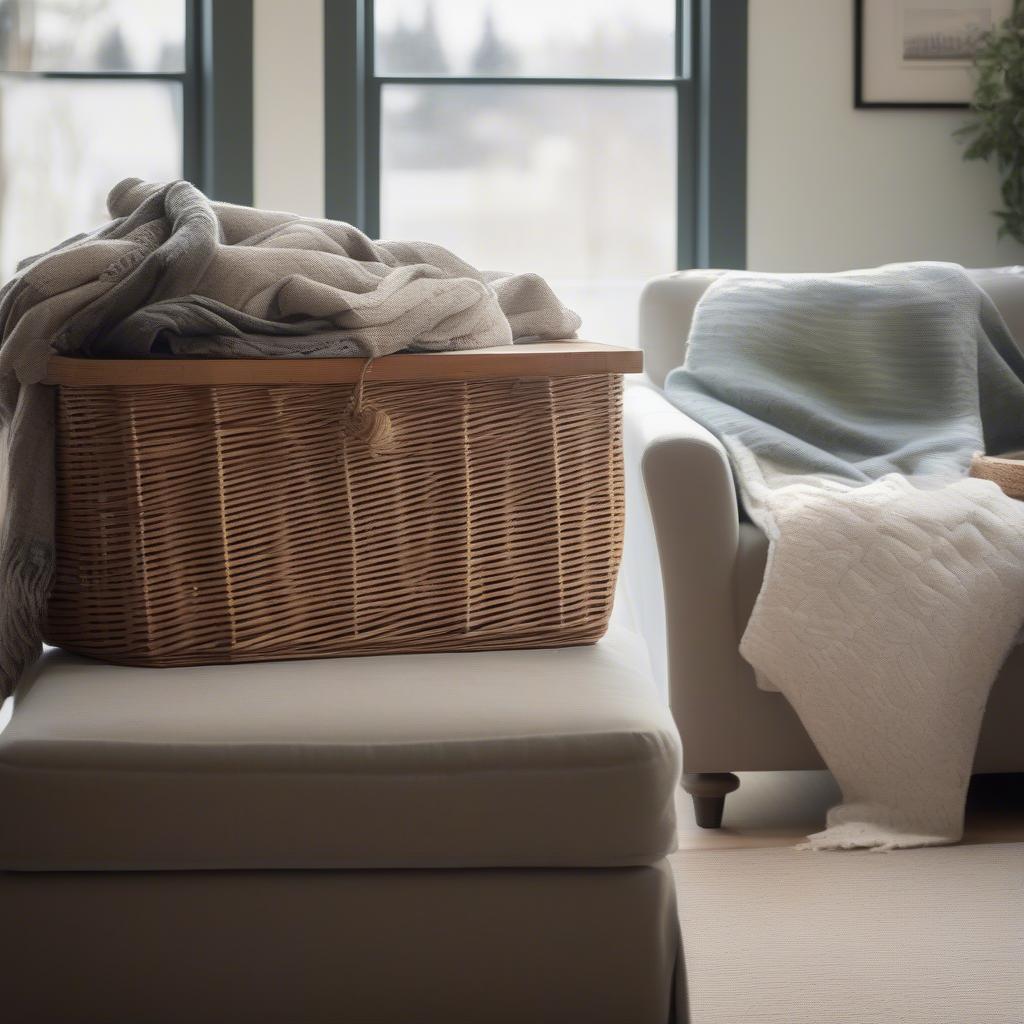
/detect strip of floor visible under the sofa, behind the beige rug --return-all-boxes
[679,771,1024,850]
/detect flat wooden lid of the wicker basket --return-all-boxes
[44,341,643,387]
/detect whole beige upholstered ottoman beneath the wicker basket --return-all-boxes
[0,630,680,1024]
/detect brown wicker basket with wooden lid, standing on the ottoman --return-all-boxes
[47,342,640,666]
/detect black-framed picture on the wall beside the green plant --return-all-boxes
[853,0,1013,108]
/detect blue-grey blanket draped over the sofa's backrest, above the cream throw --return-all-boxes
[666,263,1024,482]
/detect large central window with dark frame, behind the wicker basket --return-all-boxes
[326,0,745,342]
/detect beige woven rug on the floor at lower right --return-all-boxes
[672,843,1024,1024]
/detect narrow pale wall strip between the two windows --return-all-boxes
[253,0,324,217]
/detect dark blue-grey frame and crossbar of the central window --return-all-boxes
[324,0,748,269]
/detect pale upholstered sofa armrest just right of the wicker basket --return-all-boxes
[624,384,739,729]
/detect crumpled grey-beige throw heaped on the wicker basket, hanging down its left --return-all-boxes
[0,178,580,698]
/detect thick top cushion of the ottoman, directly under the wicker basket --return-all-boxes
[0,629,680,870]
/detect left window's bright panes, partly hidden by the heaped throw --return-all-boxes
[0,0,198,278]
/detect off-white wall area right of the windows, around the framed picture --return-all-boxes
[748,0,1024,270]
